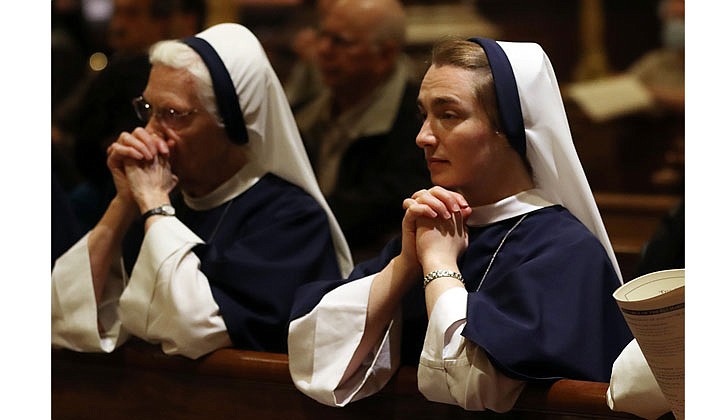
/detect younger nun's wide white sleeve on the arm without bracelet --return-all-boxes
[288,275,400,406]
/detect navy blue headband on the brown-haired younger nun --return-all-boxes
[468,38,526,158]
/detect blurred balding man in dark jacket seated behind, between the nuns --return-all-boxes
[296,0,430,260]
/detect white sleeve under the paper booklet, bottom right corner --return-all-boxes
[607,339,670,419]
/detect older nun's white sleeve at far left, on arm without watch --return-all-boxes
[51,234,128,353]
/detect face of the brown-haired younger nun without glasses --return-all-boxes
[416,66,510,205]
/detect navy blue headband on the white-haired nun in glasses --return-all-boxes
[182,36,248,144]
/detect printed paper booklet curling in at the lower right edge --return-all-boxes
[614,269,685,420]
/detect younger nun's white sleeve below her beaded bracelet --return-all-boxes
[417,288,526,412]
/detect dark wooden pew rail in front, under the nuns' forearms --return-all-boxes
[51,341,637,420]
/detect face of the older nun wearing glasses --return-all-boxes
[144,65,233,193]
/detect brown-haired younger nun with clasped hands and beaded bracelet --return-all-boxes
[288,38,631,412]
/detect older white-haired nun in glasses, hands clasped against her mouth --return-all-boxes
[51,24,352,358]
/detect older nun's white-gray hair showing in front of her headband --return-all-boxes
[149,40,224,126]
